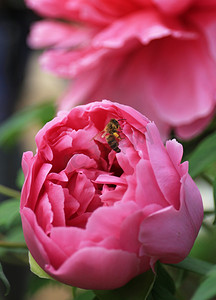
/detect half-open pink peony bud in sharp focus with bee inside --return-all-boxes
[20,100,203,289]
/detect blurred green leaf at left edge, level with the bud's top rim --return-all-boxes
[0,102,55,146]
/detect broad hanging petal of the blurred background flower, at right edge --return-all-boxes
[147,38,216,126]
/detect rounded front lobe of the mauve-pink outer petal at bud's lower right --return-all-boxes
[139,207,194,263]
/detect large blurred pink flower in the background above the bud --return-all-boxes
[26,0,216,139]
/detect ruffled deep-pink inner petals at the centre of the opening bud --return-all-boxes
[36,119,127,230]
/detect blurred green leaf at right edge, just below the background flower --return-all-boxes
[187,132,216,177]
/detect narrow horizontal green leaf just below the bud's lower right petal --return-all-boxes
[171,257,214,275]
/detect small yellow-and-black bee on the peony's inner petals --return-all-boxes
[93,119,123,153]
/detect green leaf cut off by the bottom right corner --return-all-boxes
[191,267,216,300]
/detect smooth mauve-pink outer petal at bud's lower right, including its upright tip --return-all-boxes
[139,175,203,263]
